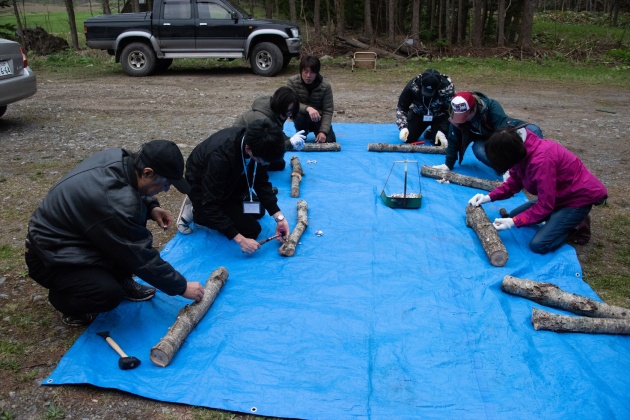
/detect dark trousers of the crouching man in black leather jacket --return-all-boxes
[24,246,132,316]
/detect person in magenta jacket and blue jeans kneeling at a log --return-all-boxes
[468,128,608,254]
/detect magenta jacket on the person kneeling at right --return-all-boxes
[489,130,608,227]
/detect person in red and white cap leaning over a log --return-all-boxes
[434,92,543,170]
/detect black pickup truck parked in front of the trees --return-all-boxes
[83,0,302,76]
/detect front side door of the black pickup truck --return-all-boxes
[195,0,252,53]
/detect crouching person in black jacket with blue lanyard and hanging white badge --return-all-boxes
[186,119,290,254]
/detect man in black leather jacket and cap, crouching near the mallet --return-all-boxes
[25,140,204,325]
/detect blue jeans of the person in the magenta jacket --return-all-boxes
[509,199,593,254]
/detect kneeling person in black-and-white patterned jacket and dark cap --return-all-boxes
[396,69,455,145]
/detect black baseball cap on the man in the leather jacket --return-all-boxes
[140,140,190,194]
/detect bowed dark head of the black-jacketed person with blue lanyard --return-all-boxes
[245,119,286,162]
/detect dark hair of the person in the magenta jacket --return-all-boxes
[485,127,527,175]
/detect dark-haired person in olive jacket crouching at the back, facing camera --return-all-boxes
[287,55,337,143]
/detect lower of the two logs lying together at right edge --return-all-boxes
[532,308,630,335]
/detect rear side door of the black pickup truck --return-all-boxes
[157,0,195,53]
